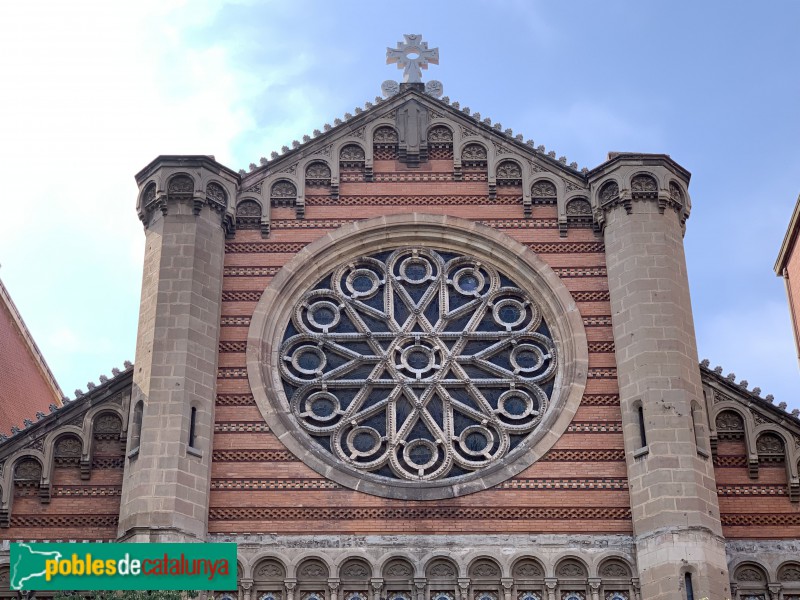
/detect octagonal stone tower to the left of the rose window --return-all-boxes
[119,156,238,541]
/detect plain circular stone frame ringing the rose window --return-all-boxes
[247,213,589,500]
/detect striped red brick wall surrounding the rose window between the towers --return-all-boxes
[209,154,632,534]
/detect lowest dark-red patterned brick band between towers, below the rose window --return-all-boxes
[208,506,636,521]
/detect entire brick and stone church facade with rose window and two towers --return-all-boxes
[0,36,800,600]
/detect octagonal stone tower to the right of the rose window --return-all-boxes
[589,154,730,600]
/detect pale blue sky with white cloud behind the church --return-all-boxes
[0,0,800,418]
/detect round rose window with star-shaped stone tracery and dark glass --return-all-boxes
[279,248,559,484]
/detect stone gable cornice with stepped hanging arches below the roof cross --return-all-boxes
[237,84,591,233]
